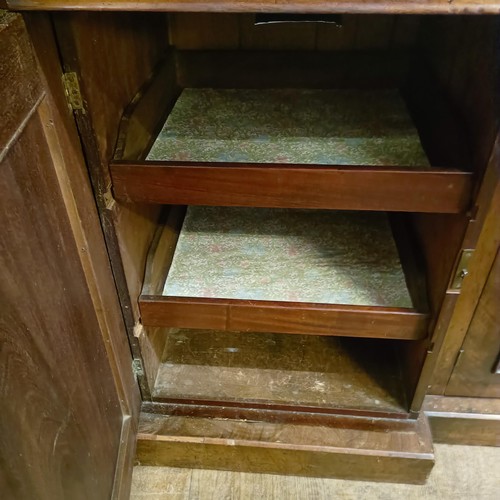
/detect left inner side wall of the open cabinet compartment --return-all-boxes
[53,12,166,398]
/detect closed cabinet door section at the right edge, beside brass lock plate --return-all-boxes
[445,250,500,398]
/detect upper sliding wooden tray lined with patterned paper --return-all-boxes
[110,52,471,213]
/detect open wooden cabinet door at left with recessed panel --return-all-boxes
[0,11,140,500]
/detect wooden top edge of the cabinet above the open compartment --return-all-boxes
[6,0,500,14]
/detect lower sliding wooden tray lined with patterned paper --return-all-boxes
[139,207,428,339]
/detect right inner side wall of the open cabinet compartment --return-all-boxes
[408,16,500,402]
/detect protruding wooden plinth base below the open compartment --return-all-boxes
[136,412,434,484]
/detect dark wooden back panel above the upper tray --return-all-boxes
[169,13,420,50]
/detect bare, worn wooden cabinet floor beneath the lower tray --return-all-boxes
[152,329,408,418]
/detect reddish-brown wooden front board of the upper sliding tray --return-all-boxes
[111,162,470,213]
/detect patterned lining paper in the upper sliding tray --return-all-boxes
[147,89,429,167]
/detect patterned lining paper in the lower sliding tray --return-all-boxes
[163,207,412,308]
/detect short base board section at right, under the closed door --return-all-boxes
[423,396,500,446]
